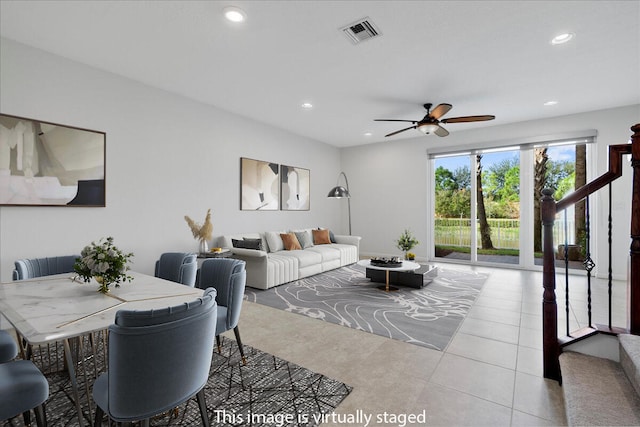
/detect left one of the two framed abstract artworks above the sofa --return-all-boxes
[240,157,280,211]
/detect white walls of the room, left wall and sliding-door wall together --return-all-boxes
[0,39,640,280]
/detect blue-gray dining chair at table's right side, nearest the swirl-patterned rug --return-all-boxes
[198,258,247,364]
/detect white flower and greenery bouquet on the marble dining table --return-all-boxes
[73,237,133,293]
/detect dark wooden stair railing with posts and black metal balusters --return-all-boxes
[540,123,640,381]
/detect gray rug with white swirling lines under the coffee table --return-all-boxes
[245,264,488,351]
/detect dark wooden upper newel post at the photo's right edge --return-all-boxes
[629,123,640,335]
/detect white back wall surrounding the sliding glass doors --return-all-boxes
[342,105,640,279]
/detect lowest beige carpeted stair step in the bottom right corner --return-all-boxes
[560,351,640,426]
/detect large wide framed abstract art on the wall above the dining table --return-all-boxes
[0,114,106,207]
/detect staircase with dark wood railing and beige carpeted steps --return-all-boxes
[541,123,640,426]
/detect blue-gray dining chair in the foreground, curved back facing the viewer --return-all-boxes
[93,289,217,426]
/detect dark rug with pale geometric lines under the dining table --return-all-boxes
[0,337,352,427]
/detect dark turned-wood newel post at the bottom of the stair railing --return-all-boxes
[540,188,560,381]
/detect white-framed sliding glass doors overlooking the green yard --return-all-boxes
[430,138,593,268]
